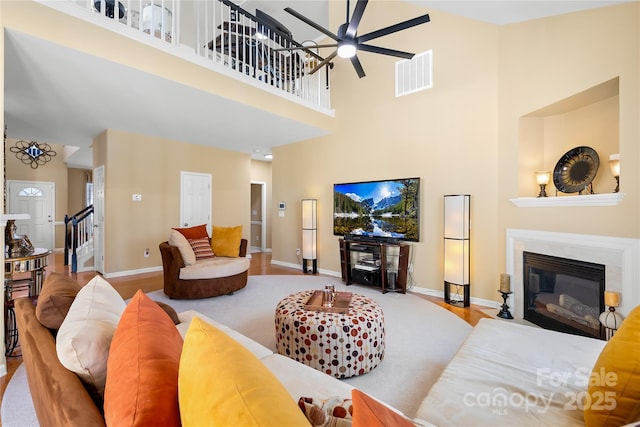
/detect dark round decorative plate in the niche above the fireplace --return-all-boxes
[553,147,600,193]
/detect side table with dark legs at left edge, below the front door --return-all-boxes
[4,248,51,356]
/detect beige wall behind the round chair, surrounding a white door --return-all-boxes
[94,129,251,274]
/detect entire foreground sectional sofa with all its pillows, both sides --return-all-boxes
[15,274,640,426]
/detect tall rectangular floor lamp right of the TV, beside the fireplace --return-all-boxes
[444,194,471,307]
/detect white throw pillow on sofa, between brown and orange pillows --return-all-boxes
[56,276,126,396]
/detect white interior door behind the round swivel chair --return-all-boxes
[180,172,211,236]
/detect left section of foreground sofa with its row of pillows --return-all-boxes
[15,273,420,427]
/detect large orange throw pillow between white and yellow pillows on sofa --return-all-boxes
[104,290,182,426]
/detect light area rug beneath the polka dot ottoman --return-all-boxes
[2,276,472,427]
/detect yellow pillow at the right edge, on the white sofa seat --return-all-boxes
[584,306,640,427]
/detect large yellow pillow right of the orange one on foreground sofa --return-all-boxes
[178,317,310,427]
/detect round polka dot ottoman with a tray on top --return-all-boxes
[275,290,385,378]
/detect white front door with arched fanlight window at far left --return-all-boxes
[7,180,56,250]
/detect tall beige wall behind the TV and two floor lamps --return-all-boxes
[273,2,499,297]
